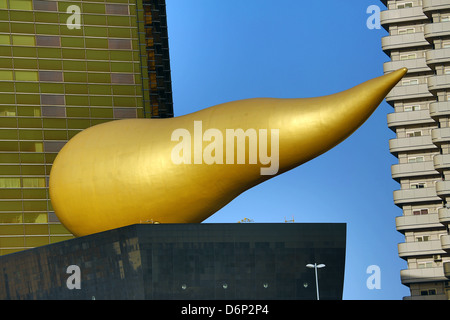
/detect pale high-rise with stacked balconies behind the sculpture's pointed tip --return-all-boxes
[381,0,450,299]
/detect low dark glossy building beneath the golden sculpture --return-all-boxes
[0,223,346,300]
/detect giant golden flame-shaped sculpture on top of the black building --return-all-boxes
[50,68,407,236]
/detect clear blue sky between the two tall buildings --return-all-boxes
[166,0,409,300]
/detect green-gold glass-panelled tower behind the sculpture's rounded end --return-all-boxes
[0,0,173,255]
